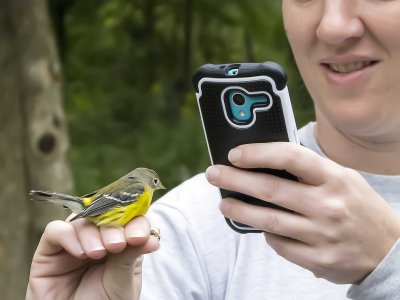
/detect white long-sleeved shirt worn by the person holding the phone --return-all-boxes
[141,123,400,300]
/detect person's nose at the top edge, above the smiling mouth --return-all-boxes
[317,0,364,45]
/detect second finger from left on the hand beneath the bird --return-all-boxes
[70,219,107,259]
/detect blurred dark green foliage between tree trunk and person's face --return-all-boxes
[63,0,312,194]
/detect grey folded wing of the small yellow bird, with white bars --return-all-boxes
[71,185,144,221]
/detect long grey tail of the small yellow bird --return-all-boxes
[29,191,84,214]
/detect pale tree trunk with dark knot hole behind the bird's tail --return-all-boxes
[0,0,72,300]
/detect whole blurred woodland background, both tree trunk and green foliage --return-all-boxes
[0,0,313,299]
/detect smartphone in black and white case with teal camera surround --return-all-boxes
[193,62,298,233]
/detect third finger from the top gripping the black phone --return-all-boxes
[220,198,315,243]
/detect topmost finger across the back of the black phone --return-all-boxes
[228,142,337,185]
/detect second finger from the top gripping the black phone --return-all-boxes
[206,165,314,215]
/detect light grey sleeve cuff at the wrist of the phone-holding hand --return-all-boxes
[347,239,400,300]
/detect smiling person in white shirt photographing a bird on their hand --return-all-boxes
[27,0,400,300]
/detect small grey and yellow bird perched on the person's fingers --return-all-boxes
[29,168,165,238]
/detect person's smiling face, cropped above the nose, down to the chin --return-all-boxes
[282,0,400,141]
